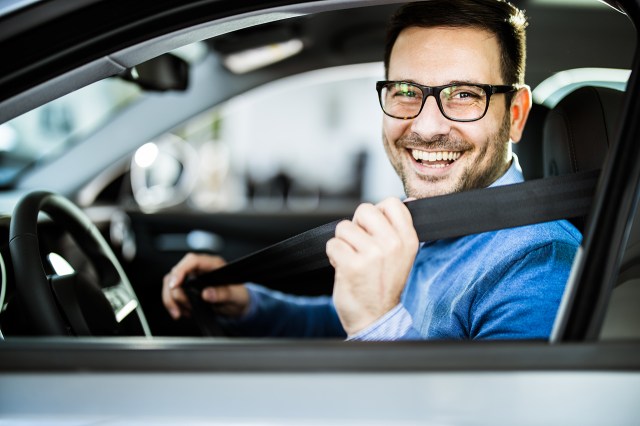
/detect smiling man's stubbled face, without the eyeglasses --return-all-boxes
[383,27,511,198]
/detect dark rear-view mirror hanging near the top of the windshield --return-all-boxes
[120,53,189,92]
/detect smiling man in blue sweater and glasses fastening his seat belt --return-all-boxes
[163,0,581,340]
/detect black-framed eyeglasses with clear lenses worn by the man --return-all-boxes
[376,81,518,121]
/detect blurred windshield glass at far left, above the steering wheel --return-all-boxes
[0,78,141,187]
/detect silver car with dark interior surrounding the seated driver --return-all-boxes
[0,0,640,425]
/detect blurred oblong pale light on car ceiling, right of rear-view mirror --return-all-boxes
[223,39,304,74]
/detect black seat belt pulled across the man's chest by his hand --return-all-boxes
[185,170,600,294]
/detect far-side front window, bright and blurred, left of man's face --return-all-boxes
[131,63,403,212]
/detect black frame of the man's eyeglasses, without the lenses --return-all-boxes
[376,80,520,123]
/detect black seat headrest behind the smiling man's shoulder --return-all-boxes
[542,86,624,177]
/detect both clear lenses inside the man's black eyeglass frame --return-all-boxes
[380,83,487,120]
